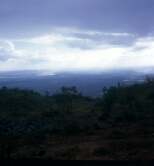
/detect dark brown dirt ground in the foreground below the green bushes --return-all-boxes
[8,126,154,160]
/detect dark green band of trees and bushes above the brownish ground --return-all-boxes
[0,78,154,136]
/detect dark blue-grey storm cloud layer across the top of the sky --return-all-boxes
[0,0,154,36]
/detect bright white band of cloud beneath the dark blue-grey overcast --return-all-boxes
[0,29,154,71]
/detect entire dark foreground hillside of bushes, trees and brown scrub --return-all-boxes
[0,78,154,159]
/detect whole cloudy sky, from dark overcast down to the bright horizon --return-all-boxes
[0,0,154,72]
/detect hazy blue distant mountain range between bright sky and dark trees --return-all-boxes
[0,70,154,96]
